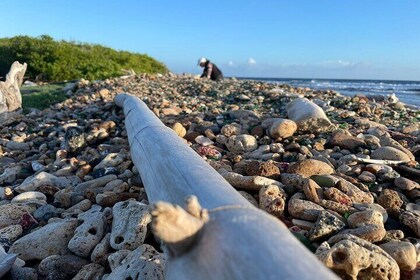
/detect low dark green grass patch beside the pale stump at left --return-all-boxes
[20,84,68,110]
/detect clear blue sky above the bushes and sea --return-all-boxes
[0,0,420,80]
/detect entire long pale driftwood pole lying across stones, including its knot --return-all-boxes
[115,94,337,279]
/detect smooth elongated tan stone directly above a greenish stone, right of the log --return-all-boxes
[287,159,334,177]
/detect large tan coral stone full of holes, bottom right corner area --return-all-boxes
[315,234,400,280]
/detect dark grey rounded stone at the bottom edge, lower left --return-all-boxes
[38,255,88,280]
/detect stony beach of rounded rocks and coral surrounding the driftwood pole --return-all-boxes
[0,73,420,280]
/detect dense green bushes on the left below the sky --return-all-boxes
[0,35,168,81]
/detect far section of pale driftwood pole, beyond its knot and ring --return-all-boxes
[116,95,249,209]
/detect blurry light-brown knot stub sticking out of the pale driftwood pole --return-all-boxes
[152,196,208,257]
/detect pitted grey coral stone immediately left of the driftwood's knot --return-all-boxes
[110,200,151,250]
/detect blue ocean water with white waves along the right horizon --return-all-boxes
[243,78,420,108]
